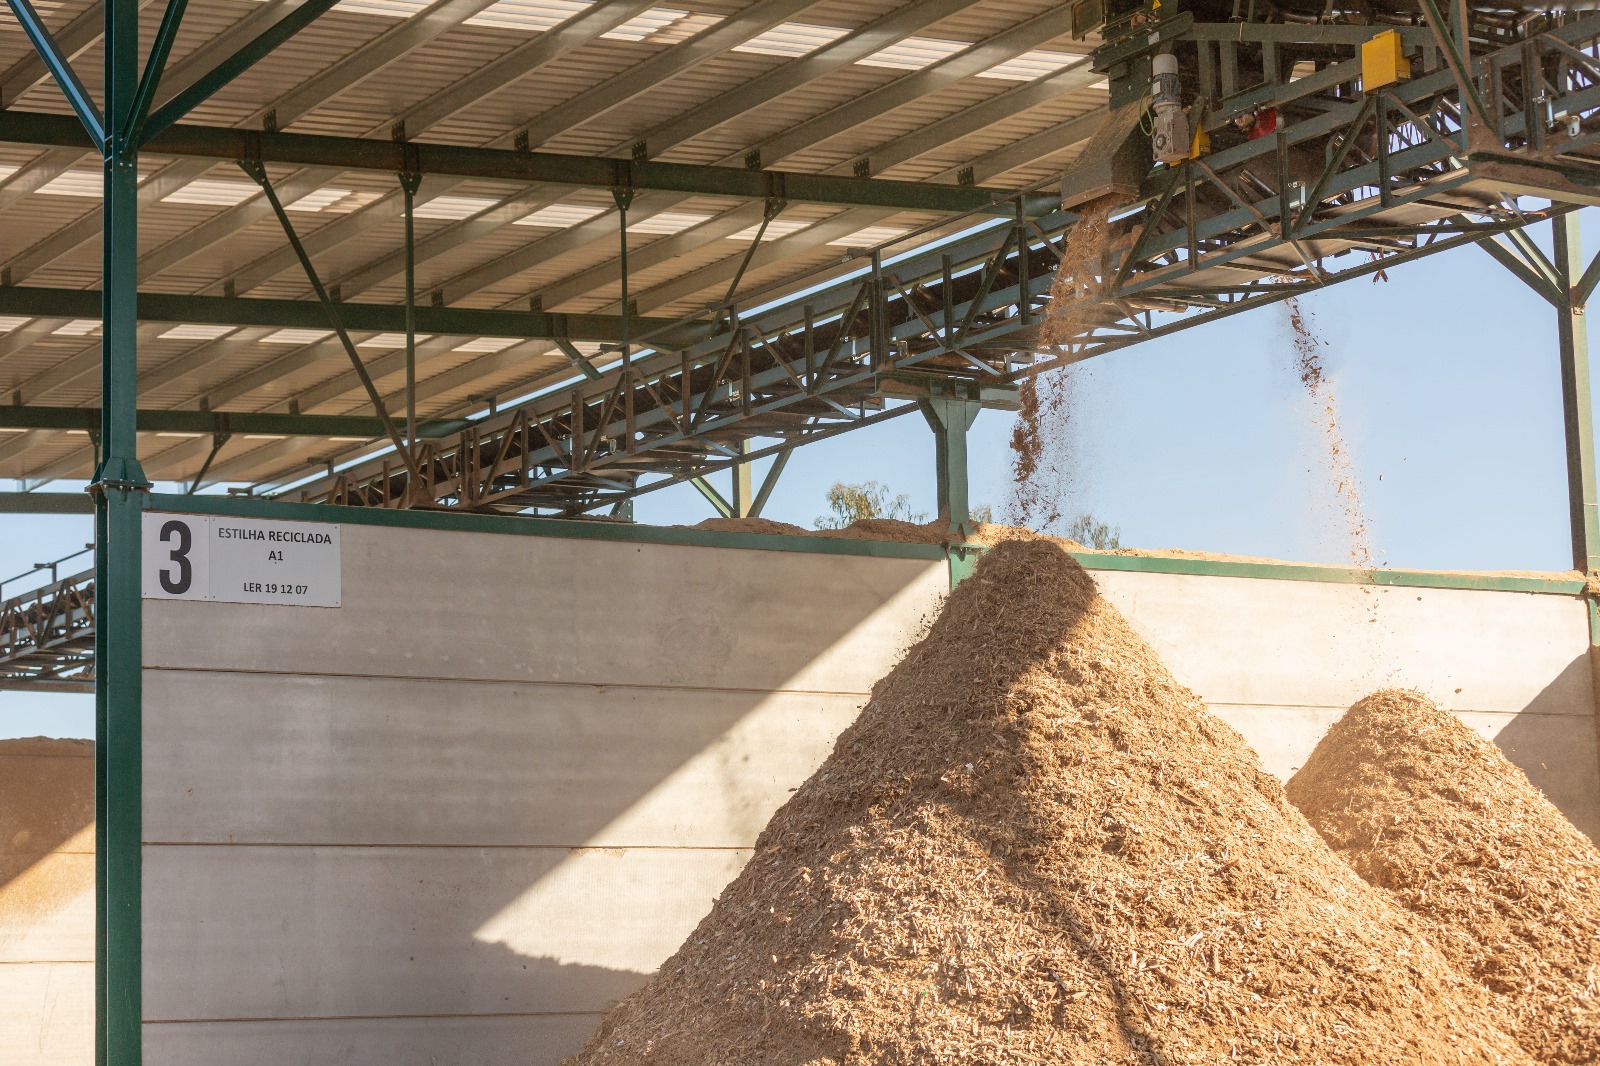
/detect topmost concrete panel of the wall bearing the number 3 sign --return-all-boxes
[144,523,947,691]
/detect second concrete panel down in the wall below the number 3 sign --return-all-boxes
[144,671,861,847]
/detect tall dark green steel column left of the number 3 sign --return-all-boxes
[91,0,149,1066]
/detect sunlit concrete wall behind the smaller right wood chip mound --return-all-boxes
[1094,571,1600,839]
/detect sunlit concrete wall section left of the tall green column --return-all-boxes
[0,739,94,1066]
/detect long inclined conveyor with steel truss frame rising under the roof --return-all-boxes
[299,18,1600,514]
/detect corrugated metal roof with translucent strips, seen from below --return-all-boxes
[0,0,1106,483]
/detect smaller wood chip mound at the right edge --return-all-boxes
[1288,690,1600,1063]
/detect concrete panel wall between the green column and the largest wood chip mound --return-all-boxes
[144,512,947,1066]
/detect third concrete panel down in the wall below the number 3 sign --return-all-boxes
[144,845,750,1017]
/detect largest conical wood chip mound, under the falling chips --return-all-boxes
[570,541,1533,1066]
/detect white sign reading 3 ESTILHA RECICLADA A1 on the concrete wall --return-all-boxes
[144,511,344,607]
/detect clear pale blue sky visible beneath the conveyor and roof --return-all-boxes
[0,211,1600,736]
